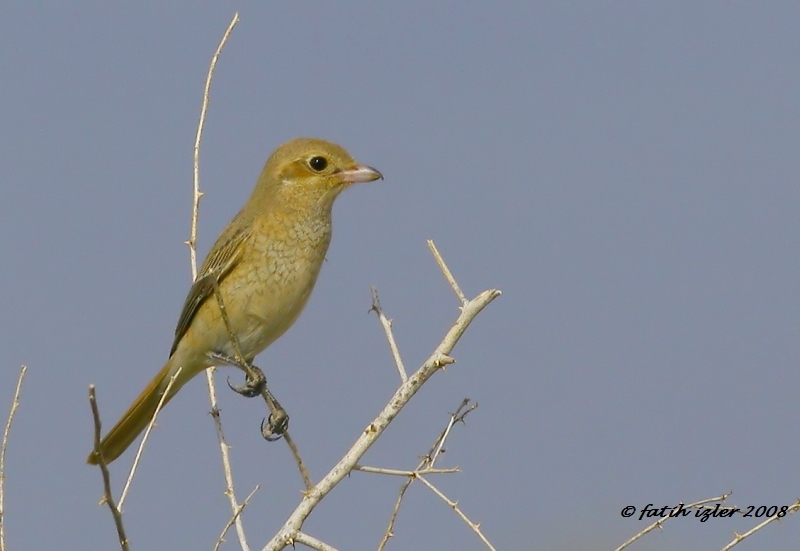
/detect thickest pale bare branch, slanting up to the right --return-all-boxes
[263,282,500,551]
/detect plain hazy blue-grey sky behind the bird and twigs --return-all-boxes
[0,1,800,551]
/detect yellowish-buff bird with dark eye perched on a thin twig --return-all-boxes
[88,138,383,464]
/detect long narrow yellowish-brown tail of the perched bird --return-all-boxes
[86,356,191,465]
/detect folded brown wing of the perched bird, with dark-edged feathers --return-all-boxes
[169,224,251,356]
